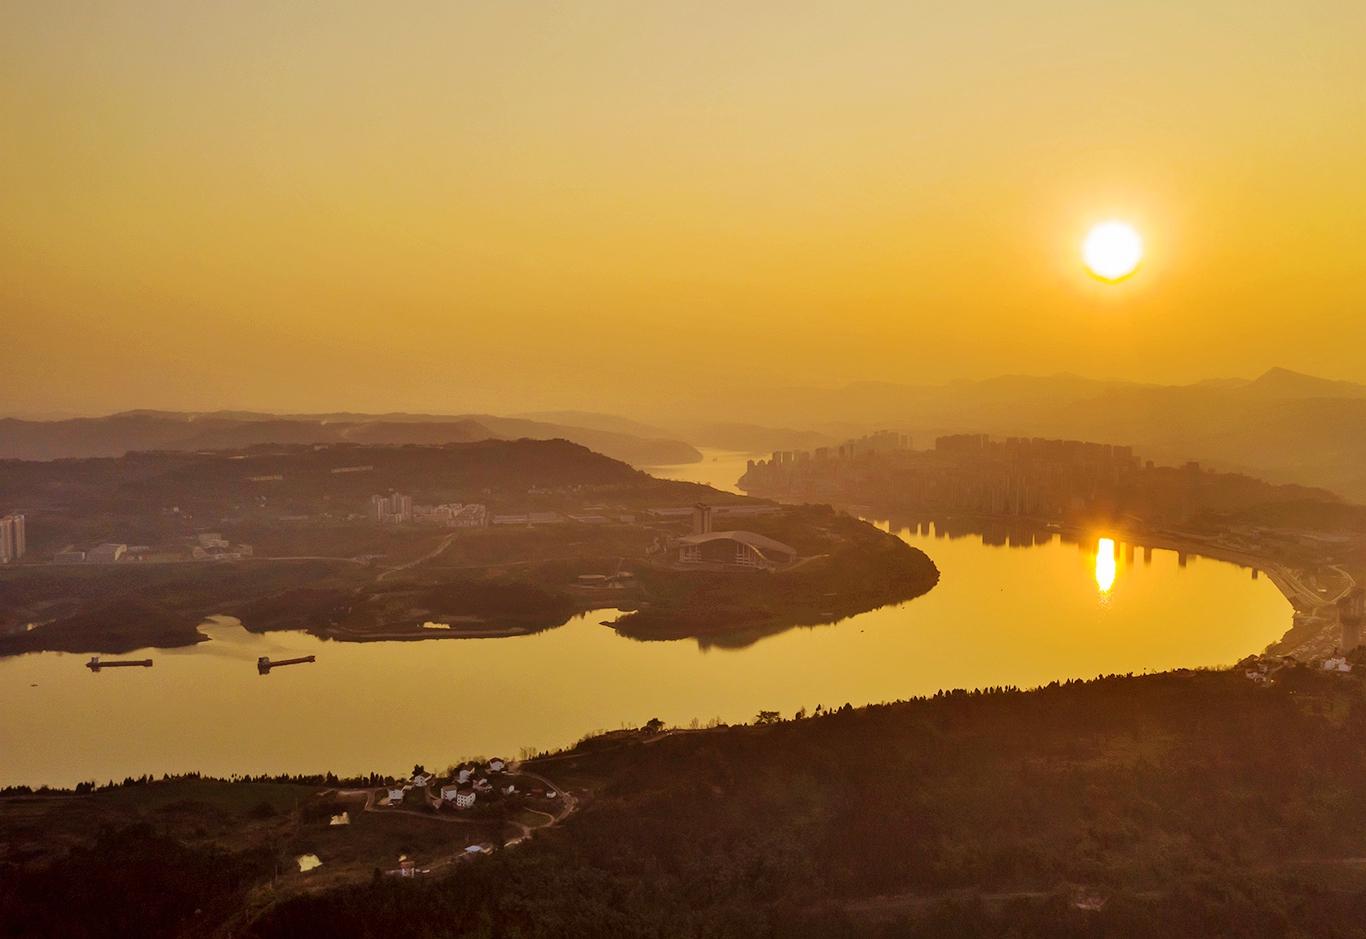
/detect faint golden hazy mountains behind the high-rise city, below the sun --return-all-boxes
[663,368,1366,502]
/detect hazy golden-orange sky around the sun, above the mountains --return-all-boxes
[0,0,1366,411]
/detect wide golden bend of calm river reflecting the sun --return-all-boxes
[0,522,1291,785]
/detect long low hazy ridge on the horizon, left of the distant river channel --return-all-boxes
[0,410,702,466]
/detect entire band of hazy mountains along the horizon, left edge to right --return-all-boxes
[10,369,1366,502]
